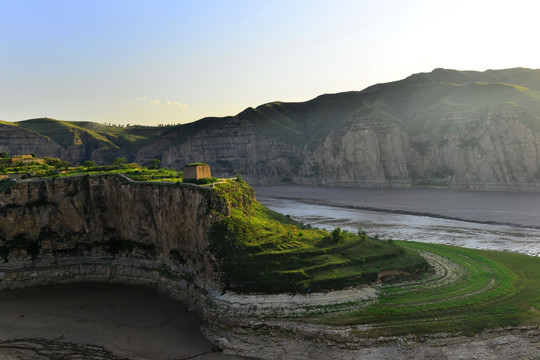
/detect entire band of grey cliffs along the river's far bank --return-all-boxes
[145,111,540,191]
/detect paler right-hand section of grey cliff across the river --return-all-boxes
[296,109,540,190]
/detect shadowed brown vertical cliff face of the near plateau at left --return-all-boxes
[0,176,229,296]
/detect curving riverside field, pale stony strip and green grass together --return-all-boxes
[213,241,540,342]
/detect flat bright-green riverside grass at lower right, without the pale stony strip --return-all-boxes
[309,242,540,336]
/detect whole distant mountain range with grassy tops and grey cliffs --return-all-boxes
[0,68,540,190]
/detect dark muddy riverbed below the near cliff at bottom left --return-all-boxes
[0,284,252,360]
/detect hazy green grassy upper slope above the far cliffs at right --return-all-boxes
[240,68,540,146]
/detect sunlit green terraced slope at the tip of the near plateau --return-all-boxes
[210,180,427,293]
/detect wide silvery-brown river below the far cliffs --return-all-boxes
[255,185,540,256]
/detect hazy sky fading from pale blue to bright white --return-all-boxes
[0,0,540,125]
